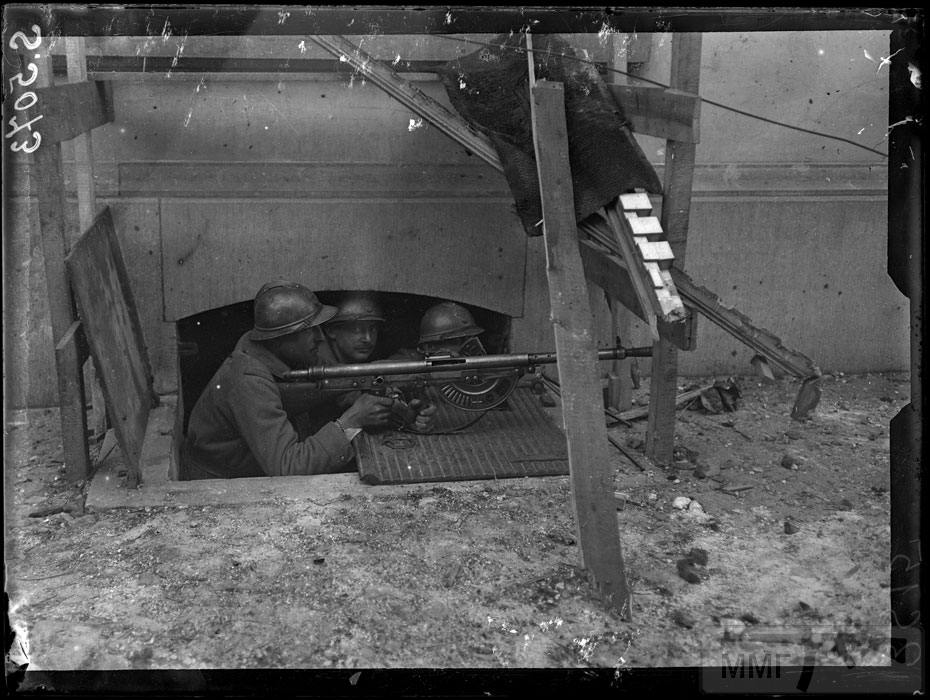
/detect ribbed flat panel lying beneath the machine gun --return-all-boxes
[358,388,568,484]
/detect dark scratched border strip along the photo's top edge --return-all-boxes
[4,3,904,36]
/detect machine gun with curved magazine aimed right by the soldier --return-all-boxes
[279,347,652,424]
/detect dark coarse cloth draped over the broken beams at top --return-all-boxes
[437,34,662,236]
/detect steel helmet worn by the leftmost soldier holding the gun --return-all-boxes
[249,280,337,340]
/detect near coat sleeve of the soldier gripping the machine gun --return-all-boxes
[230,373,354,476]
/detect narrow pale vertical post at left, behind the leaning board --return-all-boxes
[65,36,107,439]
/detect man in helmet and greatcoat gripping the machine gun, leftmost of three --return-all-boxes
[182,281,393,479]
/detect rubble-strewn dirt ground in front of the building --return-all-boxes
[5,373,909,678]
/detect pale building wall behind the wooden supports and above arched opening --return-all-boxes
[4,32,908,406]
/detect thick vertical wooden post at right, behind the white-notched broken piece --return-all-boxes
[646,33,701,464]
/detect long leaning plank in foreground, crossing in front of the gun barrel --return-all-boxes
[530,81,631,620]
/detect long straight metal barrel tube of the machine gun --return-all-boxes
[282,347,652,382]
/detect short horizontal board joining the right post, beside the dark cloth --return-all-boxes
[608,84,701,143]
